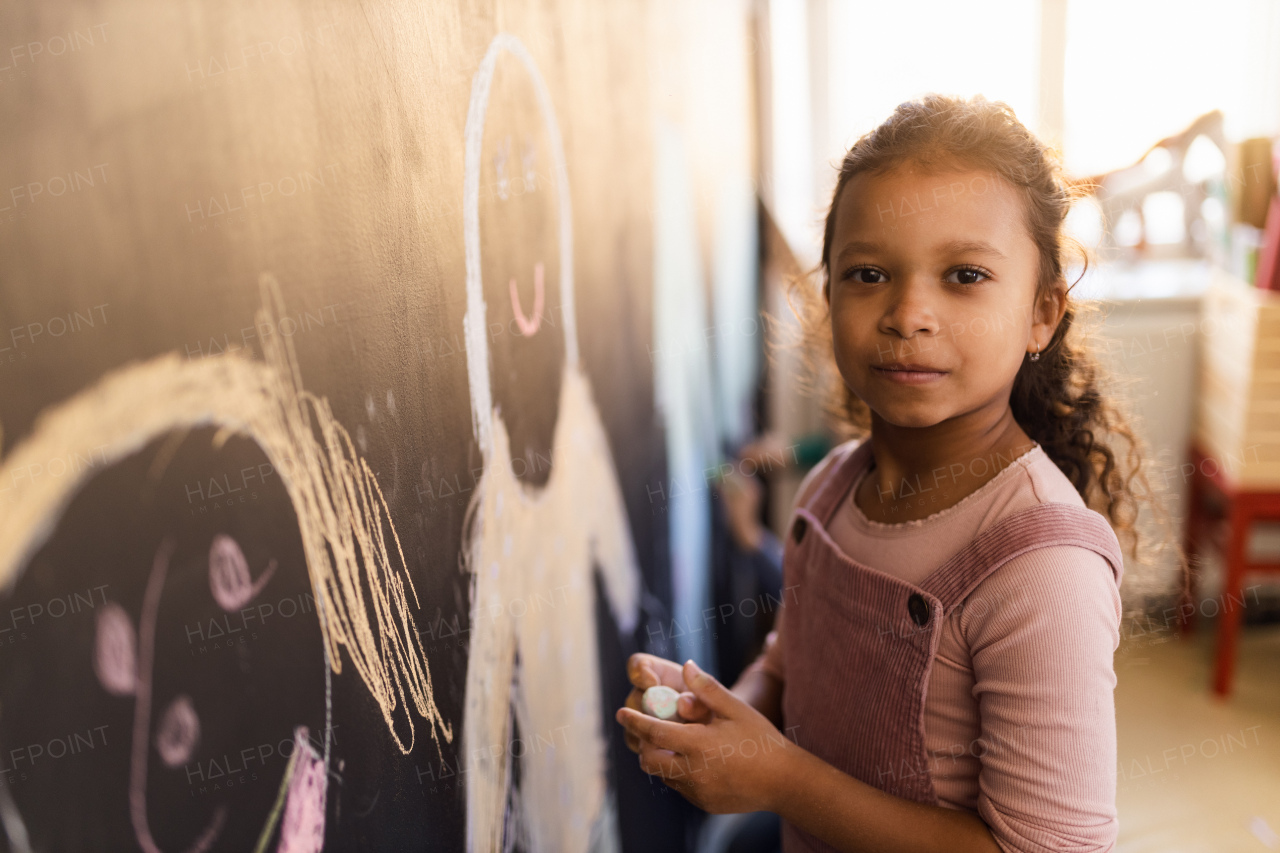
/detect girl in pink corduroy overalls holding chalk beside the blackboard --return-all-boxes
[617,95,1167,853]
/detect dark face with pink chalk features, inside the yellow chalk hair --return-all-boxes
[0,450,333,853]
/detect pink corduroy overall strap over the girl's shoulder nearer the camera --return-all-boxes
[920,503,1124,615]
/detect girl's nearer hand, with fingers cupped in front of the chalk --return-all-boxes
[616,661,797,815]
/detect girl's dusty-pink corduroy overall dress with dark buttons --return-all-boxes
[781,442,1124,853]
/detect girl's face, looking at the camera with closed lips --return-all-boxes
[827,164,1065,428]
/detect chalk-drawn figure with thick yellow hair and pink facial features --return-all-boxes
[0,273,453,853]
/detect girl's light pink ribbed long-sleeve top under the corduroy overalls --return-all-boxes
[760,446,1121,853]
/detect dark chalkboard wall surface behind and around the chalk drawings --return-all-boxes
[0,1,749,850]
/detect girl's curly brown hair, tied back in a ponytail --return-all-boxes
[788,95,1187,612]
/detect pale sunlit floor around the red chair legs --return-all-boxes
[1115,614,1280,853]
